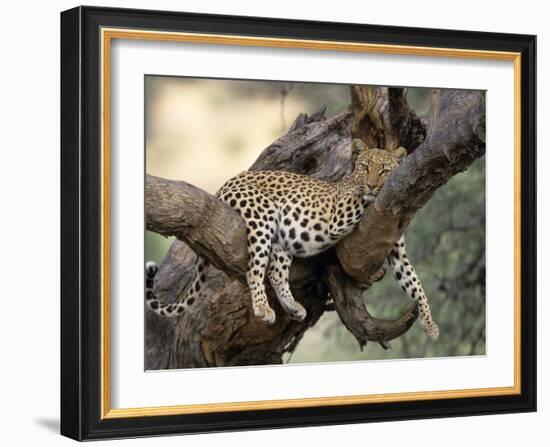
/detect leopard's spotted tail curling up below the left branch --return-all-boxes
[145,258,207,317]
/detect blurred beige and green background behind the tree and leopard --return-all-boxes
[145,76,485,363]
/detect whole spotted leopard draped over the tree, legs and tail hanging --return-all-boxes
[145,138,439,339]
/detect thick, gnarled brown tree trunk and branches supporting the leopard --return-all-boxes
[146,86,485,369]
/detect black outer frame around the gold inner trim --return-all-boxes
[61,7,536,440]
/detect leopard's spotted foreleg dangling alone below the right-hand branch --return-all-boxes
[388,236,439,339]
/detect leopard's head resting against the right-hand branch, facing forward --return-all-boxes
[351,138,407,202]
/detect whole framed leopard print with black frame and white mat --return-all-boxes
[61,7,536,440]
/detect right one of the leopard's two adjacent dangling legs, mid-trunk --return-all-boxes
[268,243,307,321]
